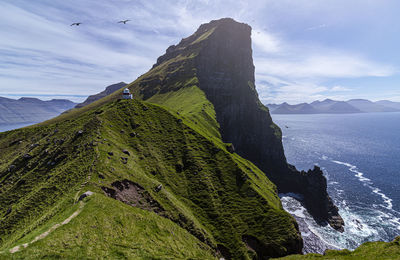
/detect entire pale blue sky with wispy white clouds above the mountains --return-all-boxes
[0,0,400,104]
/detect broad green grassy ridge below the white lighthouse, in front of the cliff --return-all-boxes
[0,99,299,259]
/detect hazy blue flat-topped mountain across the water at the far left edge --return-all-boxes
[0,97,76,124]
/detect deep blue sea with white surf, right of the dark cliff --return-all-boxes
[272,113,400,253]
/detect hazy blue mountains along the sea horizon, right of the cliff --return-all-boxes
[267,99,400,114]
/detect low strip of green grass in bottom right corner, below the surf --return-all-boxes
[279,237,400,260]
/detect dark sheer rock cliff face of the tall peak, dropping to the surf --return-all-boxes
[150,18,344,234]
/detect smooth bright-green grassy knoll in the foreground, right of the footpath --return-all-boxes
[0,194,215,259]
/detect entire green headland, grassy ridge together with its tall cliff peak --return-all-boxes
[0,18,400,259]
